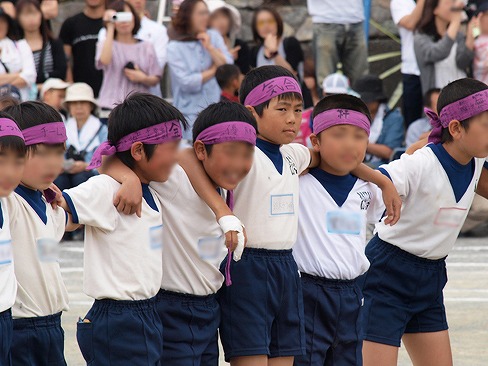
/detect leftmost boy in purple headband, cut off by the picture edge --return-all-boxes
[0,116,27,366]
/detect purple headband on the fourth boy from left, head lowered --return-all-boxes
[196,121,256,145]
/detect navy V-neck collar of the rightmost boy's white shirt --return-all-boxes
[427,144,475,202]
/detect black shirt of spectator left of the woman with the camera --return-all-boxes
[59,13,103,97]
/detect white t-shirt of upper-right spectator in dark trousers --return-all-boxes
[390,0,420,75]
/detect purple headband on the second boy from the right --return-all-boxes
[313,109,371,136]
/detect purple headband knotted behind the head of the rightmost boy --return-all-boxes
[424,90,488,144]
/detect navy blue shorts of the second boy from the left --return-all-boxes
[11,313,66,366]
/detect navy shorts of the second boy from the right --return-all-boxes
[295,273,363,366]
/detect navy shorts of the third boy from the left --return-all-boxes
[76,298,163,366]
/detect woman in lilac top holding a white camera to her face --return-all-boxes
[95,0,162,110]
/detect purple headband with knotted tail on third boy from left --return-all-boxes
[87,119,182,170]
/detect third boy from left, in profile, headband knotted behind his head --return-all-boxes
[60,93,187,366]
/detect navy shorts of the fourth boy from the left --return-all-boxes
[156,290,220,366]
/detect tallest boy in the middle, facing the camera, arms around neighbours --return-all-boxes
[179,66,399,366]
